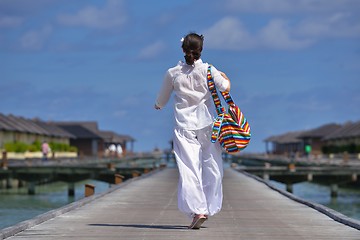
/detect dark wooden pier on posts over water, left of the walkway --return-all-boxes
[0,156,164,196]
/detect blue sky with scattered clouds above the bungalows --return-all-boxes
[0,0,360,152]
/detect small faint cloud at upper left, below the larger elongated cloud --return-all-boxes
[20,25,53,50]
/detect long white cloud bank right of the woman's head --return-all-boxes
[203,7,360,50]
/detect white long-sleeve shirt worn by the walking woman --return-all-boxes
[156,59,229,130]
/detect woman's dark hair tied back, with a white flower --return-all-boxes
[181,33,204,65]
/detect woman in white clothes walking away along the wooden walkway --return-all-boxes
[155,33,230,229]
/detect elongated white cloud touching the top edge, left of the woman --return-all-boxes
[58,0,127,29]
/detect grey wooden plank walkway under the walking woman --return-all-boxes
[0,168,360,240]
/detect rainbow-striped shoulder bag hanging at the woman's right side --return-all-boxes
[207,65,251,153]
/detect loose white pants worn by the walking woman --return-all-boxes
[174,125,223,217]
